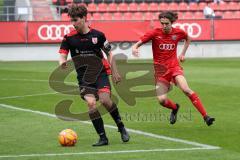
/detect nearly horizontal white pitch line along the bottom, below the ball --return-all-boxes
[0,148,218,158]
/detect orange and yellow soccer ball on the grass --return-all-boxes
[58,129,77,146]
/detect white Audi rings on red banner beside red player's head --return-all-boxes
[173,23,202,38]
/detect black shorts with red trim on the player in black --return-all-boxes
[78,73,111,100]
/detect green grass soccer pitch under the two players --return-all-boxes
[0,58,240,160]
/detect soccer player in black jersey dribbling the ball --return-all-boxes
[59,4,130,146]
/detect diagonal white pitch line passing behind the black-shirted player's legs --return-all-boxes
[0,104,220,149]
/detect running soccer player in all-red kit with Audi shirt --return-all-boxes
[132,11,215,126]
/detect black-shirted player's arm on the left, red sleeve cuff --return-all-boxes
[58,36,69,69]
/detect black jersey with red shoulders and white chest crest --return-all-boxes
[59,28,111,81]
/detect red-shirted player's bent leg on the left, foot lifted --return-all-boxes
[156,81,179,124]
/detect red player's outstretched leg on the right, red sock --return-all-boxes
[175,75,214,125]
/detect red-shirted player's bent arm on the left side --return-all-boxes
[132,30,155,57]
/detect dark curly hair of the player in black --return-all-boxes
[68,4,87,18]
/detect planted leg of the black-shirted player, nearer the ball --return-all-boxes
[83,91,108,146]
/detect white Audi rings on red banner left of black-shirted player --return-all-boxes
[38,25,73,40]
